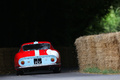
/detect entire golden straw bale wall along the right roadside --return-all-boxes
[75,32,120,71]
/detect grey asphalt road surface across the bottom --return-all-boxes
[0,69,120,80]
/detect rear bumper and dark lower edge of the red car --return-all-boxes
[16,63,61,71]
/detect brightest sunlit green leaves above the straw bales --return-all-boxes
[100,7,120,33]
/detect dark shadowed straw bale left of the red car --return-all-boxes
[0,48,18,74]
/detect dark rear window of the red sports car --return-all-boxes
[23,43,50,51]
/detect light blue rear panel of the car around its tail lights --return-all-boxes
[18,55,57,67]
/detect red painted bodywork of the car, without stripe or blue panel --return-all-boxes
[14,41,61,70]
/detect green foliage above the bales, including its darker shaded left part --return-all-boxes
[86,6,120,34]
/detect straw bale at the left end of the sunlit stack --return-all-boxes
[75,36,96,69]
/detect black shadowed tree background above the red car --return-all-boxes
[0,0,115,47]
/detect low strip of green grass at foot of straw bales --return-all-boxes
[83,67,120,74]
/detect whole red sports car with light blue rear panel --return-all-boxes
[14,41,61,75]
